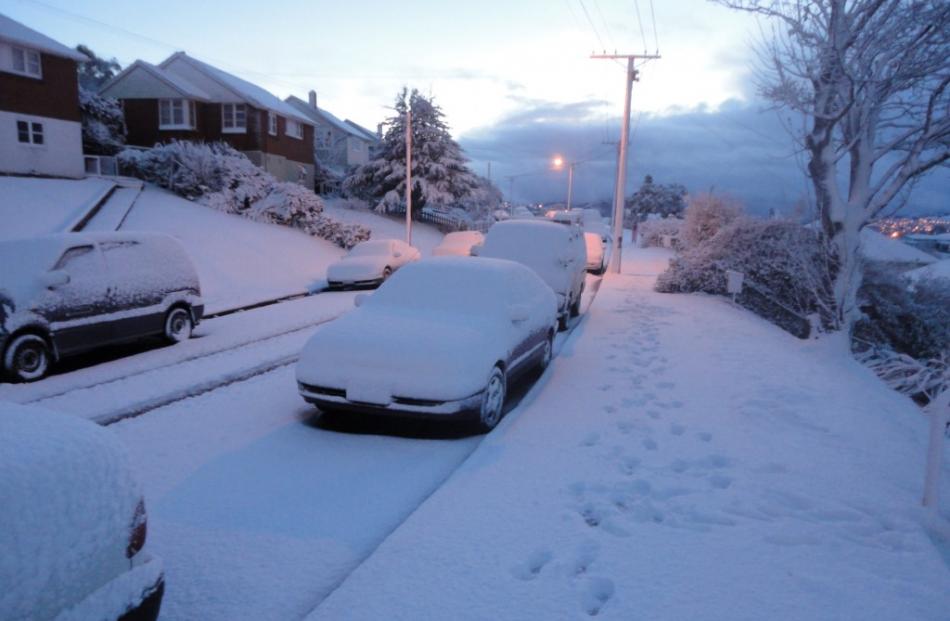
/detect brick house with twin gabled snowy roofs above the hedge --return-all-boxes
[99,52,314,187]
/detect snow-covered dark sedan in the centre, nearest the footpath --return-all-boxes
[297,257,557,431]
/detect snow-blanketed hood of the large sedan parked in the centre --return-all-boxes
[297,308,510,401]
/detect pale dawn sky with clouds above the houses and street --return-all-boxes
[0,0,950,212]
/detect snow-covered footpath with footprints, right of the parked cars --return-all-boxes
[309,251,950,621]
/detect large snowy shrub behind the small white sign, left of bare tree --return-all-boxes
[656,218,834,338]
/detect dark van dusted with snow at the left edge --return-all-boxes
[0,233,204,381]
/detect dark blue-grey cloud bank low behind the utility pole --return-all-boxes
[460,99,950,214]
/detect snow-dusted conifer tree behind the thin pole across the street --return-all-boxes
[344,88,479,213]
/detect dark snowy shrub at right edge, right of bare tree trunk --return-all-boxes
[852,264,950,401]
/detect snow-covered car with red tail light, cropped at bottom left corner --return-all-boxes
[0,403,165,621]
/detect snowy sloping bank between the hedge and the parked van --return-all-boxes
[116,184,343,313]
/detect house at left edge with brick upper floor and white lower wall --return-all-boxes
[0,15,86,177]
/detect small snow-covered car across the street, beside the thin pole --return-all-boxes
[327,239,422,289]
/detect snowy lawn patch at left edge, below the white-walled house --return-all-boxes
[0,177,114,240]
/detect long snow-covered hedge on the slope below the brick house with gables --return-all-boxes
[119,141,370,248]
